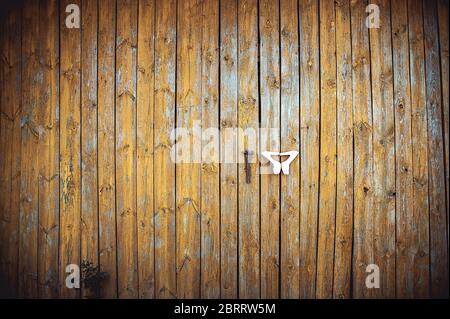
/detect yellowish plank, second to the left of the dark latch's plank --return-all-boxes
[200,0,220,298]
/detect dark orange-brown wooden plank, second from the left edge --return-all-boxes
[19,0,43,298]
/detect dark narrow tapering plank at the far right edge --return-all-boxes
[438,0,450,247]
